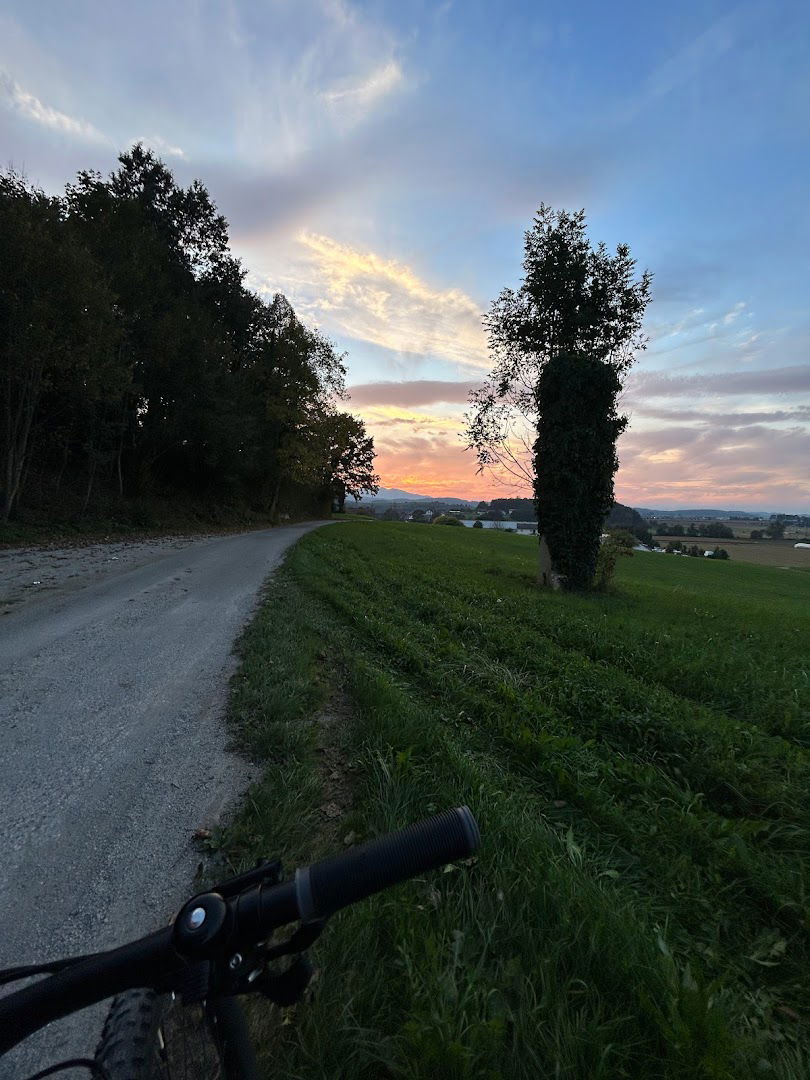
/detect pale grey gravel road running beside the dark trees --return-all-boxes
[0,525,330,1080]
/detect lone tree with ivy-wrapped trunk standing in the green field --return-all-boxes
[467,205,651,589]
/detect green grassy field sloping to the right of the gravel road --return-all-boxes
[219,523,810,1080]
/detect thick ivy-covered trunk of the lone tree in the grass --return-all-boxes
[535,353,626,589]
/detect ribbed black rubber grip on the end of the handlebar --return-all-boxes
[295,807,481,922]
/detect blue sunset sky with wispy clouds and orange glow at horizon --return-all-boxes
[0,0,810,512]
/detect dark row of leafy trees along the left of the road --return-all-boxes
[0,144,378,521]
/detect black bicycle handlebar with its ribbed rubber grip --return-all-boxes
[0,807,481,1055]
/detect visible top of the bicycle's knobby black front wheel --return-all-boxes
[95,990,226,1080]
